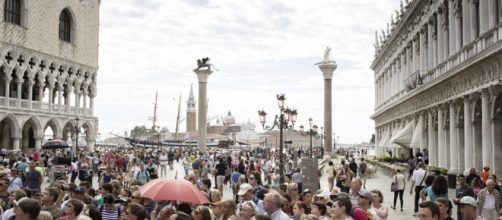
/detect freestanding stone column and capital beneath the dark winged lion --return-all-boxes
[193,68,213,154]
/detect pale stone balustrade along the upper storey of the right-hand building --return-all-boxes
[375,23,502,111]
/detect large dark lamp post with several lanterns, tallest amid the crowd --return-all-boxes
[258,94,298,184]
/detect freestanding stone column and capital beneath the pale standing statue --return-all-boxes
[319,62,336,155]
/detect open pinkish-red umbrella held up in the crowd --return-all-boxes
[140,178,209,204]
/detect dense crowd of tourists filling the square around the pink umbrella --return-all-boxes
[0,148,502,220]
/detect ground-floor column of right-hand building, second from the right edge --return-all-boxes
[464,96,474,169]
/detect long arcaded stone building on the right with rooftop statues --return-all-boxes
[371,0,502,174]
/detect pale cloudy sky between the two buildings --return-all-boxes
[94,0,399,143]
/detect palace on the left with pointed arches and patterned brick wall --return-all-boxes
[0,0,100,151]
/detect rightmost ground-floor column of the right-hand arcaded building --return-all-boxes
[481,89,493,167]
